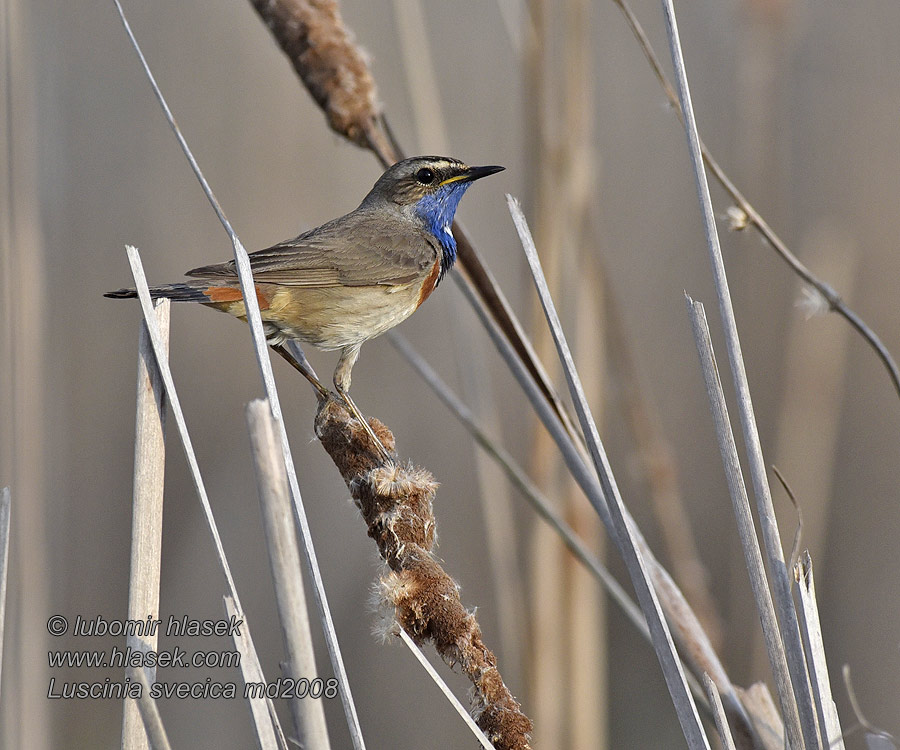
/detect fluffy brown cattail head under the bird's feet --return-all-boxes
[315,400,532,750]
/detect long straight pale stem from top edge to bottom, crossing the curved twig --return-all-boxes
[663,0,821,750]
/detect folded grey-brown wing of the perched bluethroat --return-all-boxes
[186,210,439,287]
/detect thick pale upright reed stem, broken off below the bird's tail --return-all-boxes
[122,300,171,750]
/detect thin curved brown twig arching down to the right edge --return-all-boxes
[613,0,900,406]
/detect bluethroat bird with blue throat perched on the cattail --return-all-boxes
[105,156,503,450]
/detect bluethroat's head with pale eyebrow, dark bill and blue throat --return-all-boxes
[363,156,504,270]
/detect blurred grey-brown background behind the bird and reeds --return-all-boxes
[0,0,900,750]
